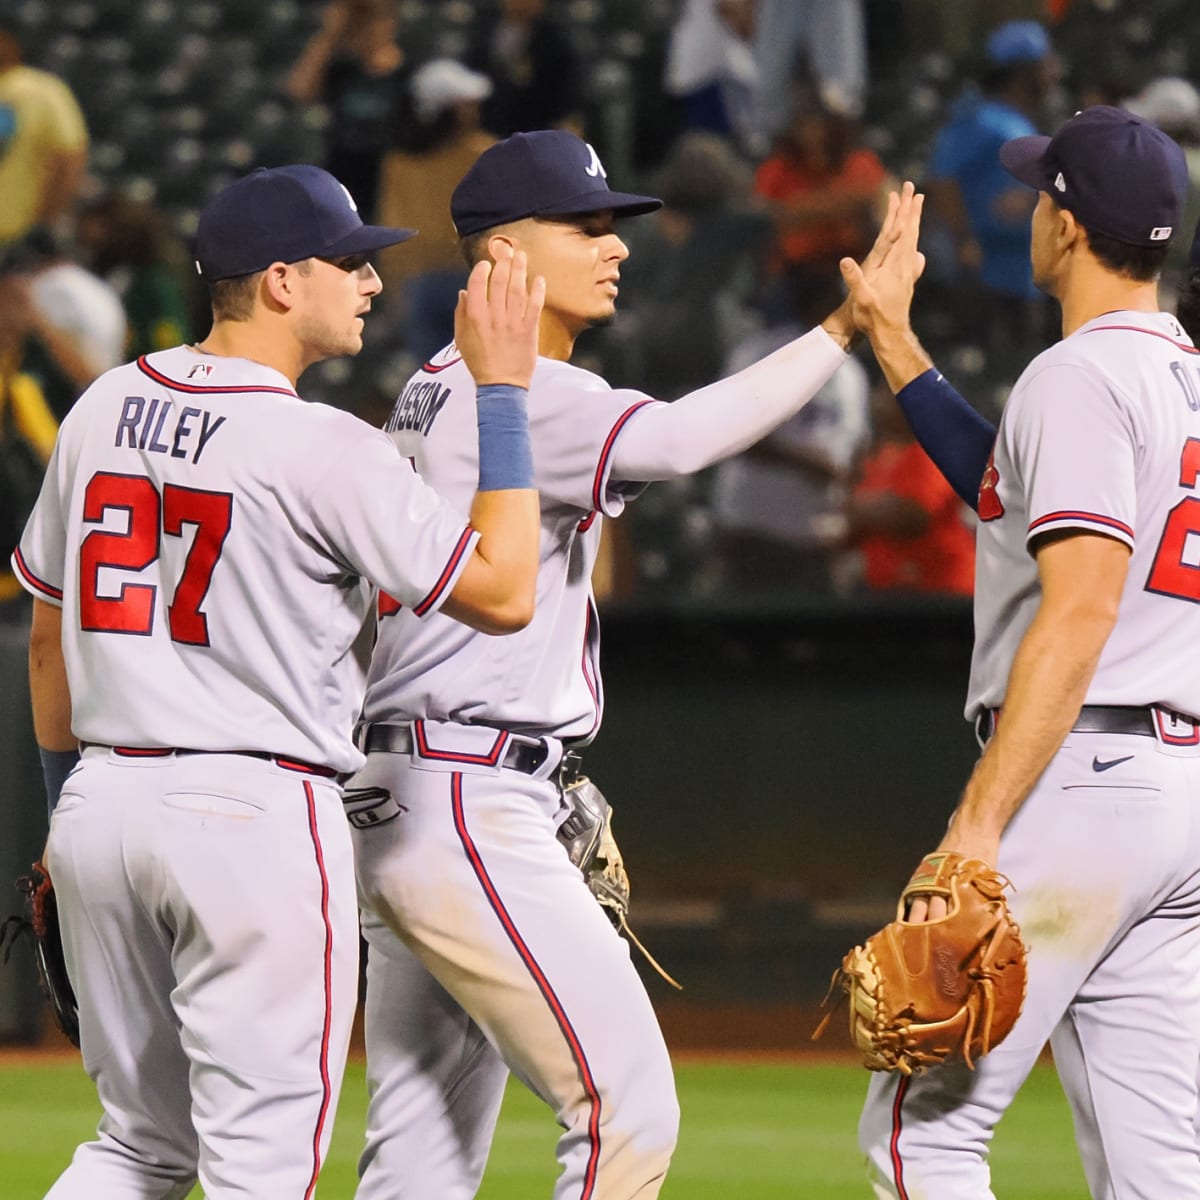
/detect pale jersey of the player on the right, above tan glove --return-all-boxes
[967,312,1200,718]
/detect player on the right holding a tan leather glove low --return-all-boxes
[846,107,1200,1200]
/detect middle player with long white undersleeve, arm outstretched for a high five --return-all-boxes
[347,131,912,1200]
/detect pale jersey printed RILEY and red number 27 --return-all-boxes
[13,347,478,772]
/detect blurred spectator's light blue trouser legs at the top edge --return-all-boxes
[754,0,868,138]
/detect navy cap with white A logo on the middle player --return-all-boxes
[450,130,662,238]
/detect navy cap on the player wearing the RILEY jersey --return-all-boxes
[196,163,416,281]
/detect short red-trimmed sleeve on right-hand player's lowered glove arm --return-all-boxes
[1002,362,1141,547]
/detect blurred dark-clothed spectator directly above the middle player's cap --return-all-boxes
[467,0,583,138]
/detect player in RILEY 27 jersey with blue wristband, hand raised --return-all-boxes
[13,166,541,1200]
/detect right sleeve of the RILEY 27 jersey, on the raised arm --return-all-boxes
[304,418,479,617]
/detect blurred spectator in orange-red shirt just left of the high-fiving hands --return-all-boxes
[755,88,890,292]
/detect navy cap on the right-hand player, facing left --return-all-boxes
[1000,104,1188,246]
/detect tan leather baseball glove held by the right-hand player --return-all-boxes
[814,853,1026,1075]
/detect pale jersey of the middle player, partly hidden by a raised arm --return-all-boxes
[364,344,656,740]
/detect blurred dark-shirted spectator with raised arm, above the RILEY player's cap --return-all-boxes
[286,0,408,222]
